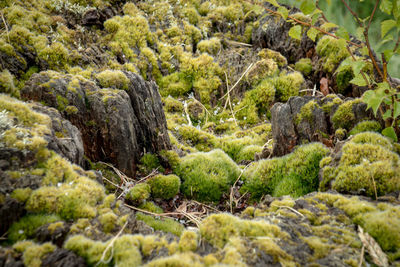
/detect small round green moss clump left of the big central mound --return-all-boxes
[147,174,181,199]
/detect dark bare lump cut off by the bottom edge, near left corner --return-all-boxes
[41,248,86,267]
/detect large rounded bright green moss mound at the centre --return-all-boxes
[176,149,240,201]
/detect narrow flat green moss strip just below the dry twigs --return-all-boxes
[136,212,184,236]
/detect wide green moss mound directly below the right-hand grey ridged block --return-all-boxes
[241,143,328,198]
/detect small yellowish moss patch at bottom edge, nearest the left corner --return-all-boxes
[15,242,56,267]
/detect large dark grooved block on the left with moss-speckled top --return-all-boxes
[21,72,170,176]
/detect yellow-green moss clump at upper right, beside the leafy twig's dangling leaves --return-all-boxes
[315,35,350,73]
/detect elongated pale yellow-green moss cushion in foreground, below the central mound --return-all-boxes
[200,214,288,248]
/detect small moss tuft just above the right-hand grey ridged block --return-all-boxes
[272,72,304,102]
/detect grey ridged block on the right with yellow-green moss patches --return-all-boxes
[271,96,374,156]
